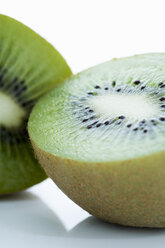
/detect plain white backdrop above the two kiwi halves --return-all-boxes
[0,0,165,73]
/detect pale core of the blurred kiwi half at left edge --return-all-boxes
[0,92,26,127]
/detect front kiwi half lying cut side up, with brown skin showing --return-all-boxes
[28,53,165,227]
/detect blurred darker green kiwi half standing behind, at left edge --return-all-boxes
[0,15,71,194]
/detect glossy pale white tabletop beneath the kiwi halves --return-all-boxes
[0,179,165,248]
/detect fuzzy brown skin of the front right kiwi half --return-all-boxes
[31,139,165,228]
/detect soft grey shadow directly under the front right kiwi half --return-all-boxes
[69,216,165,240]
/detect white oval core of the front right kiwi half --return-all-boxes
[89,94,160,120]
